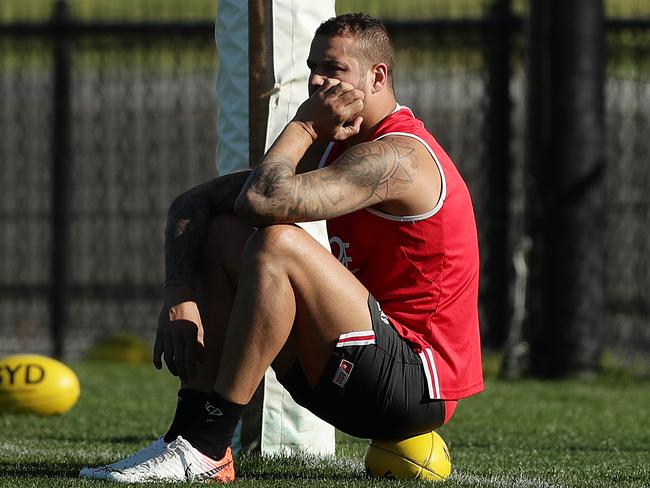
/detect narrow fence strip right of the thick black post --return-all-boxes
[604,21,650,366]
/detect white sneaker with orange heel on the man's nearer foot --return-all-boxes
[106,436,235,483]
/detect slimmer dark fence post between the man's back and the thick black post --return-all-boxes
[485,0,512,348]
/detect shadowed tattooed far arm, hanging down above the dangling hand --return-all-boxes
[165,172,249,287]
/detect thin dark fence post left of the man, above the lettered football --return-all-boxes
[50,0,71,357]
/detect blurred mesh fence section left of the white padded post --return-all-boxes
[0,2,217,356]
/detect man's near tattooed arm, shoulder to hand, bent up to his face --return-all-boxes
[235,79,440,226]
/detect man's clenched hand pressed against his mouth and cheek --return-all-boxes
[294,78,365,141]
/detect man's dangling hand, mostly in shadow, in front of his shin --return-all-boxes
[153,288,203,379]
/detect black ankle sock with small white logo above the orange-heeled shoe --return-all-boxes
[181,392,246,460]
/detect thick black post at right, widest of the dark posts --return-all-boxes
[527,0,605,377]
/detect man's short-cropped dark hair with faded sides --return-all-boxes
[315,12,394,88]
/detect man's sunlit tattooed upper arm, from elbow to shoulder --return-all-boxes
[235,138,418,225]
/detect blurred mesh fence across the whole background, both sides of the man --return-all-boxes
[0,0,650,368]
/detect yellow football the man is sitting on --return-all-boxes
[364,432,451,481]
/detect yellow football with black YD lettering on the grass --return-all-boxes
[0,354,80,415]
